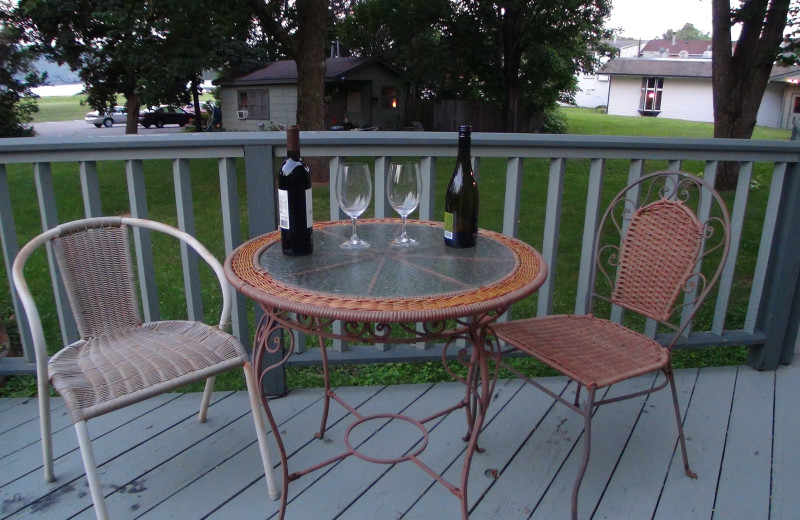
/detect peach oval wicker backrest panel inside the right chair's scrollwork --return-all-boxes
[611,199,704,322]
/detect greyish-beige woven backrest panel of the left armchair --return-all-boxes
[53,225,142,339]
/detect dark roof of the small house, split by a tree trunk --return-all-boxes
[215,56,400,85]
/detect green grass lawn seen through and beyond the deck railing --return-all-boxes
[0,107,790,396]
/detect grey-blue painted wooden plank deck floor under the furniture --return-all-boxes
[0,362,800,520]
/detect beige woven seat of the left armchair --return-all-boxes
[49,321,248,422]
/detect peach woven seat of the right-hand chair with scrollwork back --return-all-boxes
[493,315,669,388]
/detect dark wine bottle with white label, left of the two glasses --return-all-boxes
[278,125,314,256]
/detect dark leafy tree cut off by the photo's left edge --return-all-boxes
[0,0,46,137]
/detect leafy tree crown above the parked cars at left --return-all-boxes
[18,0,250,133]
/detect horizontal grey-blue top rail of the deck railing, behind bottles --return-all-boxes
[0,131,800,164]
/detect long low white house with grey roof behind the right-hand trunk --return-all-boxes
[599,58,800,129]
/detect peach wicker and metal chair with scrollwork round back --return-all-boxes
[493,171,730,520]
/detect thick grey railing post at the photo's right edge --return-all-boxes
[747,163,800,370]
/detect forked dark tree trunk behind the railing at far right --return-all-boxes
[711,0,790,190]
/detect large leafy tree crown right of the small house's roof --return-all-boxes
[337,0,611,132]
